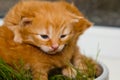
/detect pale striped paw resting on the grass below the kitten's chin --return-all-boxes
[62,67,77,78]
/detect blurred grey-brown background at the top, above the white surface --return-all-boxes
[0,0,120,27]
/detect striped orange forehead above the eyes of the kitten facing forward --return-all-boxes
[33,17,71,37]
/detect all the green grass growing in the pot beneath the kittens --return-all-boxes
[0,59,95,80]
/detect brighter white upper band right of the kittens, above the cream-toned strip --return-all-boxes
[78,26,120,58]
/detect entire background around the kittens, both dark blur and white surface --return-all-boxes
[0,0,120,80]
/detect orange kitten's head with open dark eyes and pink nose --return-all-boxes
[14,17,76,54]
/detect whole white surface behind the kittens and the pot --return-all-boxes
[0,20,120,80]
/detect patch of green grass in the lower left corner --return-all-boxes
[0,59,32,80]
